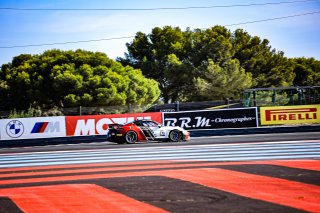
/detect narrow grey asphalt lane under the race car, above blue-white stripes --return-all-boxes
[0,131,320,154]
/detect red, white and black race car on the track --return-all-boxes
[107,120,190,143]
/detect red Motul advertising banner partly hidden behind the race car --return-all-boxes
[66,112,162,136]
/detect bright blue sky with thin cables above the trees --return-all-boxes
[0,0,320,66]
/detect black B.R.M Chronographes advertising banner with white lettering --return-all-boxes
[163,107,258,130]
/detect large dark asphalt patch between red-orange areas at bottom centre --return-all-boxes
[95,176,304,213]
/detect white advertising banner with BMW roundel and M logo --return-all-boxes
[0,116,66,140]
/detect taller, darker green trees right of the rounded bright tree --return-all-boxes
[118,26,320,102]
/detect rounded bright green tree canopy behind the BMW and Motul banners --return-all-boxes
[0,50,160,110]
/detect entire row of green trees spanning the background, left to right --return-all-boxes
[0,26,320,110]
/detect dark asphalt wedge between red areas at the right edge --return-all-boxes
[215,164,320,185]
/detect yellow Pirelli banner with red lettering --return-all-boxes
[260,105,320,125]
